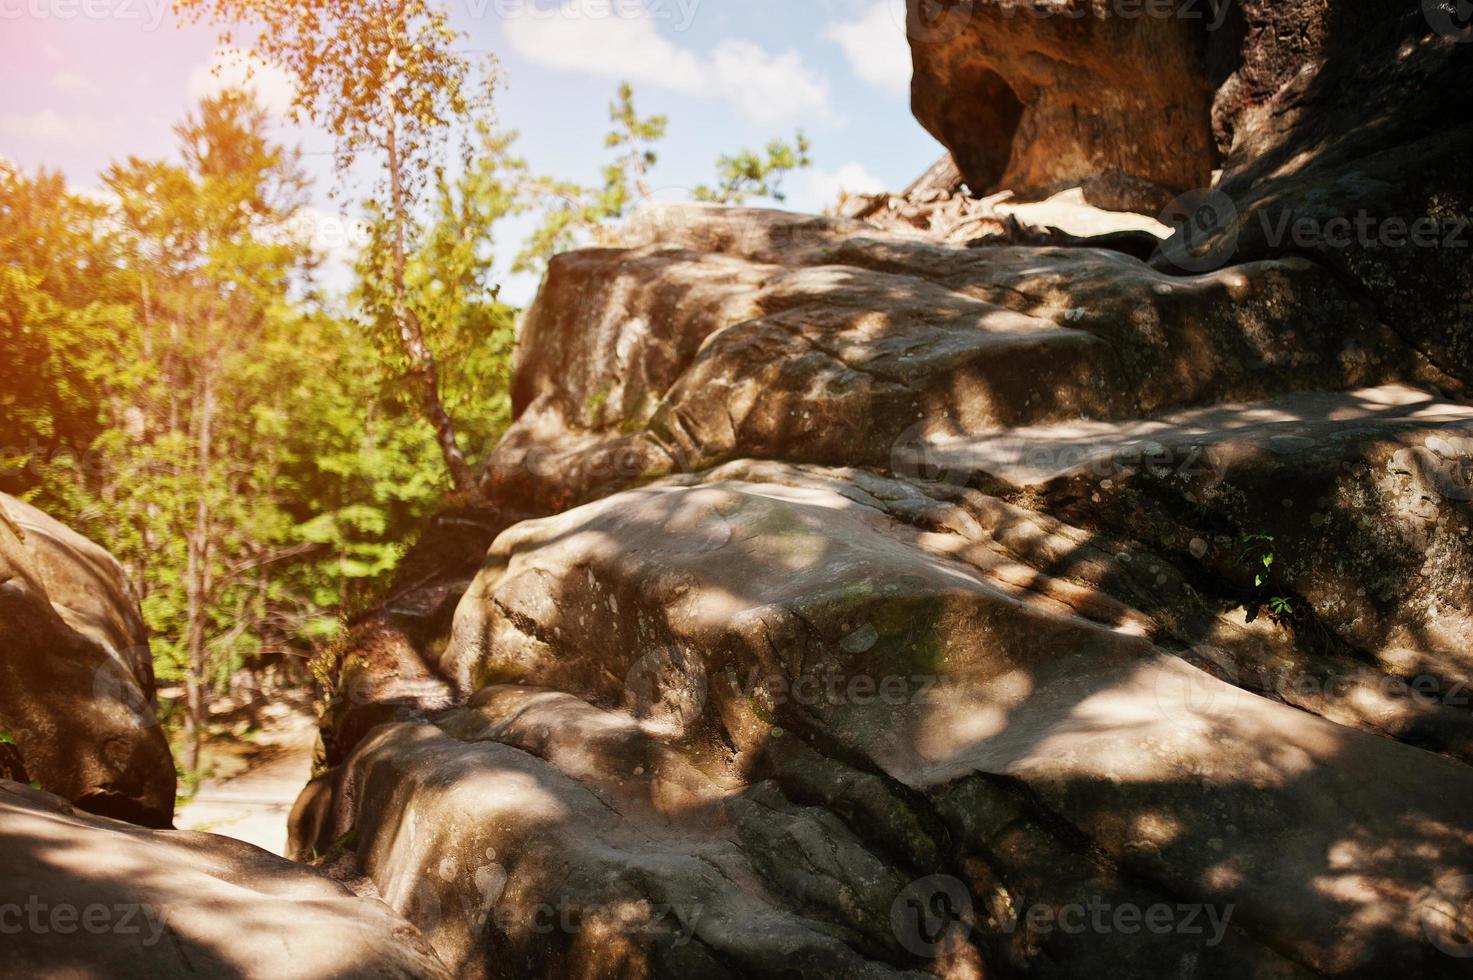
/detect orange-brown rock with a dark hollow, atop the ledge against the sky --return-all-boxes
[907,0,1217,201]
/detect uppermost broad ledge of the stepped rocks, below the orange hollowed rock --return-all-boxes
[488,205,1445,516]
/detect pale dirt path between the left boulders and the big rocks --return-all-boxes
[174,706,317,855]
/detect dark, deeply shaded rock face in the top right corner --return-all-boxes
[1158,12,1473,385]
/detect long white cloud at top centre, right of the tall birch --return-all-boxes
[507,1,837,125]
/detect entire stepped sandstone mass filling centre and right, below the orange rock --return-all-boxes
[293,206,1473,977]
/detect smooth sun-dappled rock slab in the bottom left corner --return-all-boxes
[0,781,449,980]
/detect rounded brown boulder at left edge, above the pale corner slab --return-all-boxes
[0,495,175,827]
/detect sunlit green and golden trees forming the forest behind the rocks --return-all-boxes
[0,24,809,784]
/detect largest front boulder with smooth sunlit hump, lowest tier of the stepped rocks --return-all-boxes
[296,463,1473,977]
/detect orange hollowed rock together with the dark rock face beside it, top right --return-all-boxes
[909,0,1473,383]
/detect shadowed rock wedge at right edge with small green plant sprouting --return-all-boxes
[910,385,1473,762]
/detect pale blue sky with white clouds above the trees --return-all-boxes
[0,0,941,301]
